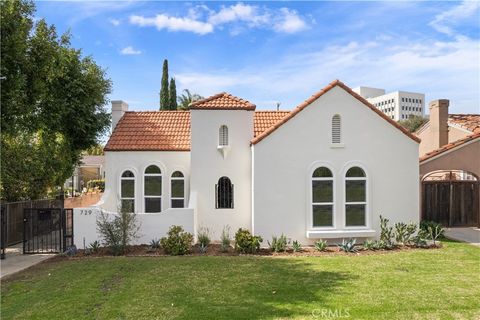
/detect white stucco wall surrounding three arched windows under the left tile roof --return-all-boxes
[101,151,190,213]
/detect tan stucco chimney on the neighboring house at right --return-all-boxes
[429,99,449,149]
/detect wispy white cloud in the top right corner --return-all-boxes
[430,1,480,36]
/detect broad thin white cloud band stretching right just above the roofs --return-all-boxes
[176,37,480,113]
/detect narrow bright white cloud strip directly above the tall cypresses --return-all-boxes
[130,14,213,35]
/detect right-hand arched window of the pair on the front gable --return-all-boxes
[345,167,367,227]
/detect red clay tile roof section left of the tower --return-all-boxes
[104,111,190,151]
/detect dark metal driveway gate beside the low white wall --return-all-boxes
[23,208,73,254]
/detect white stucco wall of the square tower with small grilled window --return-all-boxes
[190,110,253,240]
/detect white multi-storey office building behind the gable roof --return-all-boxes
[353,87,425,121]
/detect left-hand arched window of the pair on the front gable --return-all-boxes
[312,167,333,227]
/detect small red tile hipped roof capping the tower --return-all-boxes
[190,92,256,110]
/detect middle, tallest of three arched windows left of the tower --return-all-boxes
[143,165,162,212]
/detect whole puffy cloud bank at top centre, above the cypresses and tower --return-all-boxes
[130,3,308,35]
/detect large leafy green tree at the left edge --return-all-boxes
[0,0,111,201]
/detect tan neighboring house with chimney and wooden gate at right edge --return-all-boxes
[416,100,480,227]
